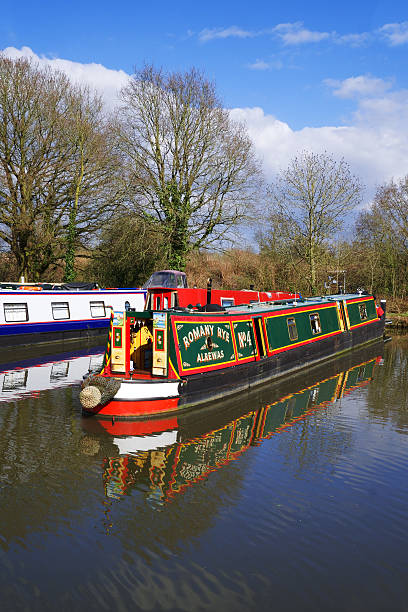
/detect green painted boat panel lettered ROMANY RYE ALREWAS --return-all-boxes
[175,321,235,371]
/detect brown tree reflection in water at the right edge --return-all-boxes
[367,335,408,433]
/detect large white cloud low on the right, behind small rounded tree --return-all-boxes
[231,100,408,201]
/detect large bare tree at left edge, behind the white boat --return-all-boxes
[0,55,119,280]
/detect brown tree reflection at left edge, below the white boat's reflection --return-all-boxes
[0,387,101,548]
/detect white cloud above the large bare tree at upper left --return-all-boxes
[3,47,129,108]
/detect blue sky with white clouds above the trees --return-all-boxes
[0,0,408,213]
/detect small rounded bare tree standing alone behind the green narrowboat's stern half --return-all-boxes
[269,151,362,293]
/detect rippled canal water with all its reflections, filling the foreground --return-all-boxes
[0,336,408,612]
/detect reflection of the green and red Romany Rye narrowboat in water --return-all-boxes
[82,345,382,503]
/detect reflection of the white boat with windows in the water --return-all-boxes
[0,346,103,402]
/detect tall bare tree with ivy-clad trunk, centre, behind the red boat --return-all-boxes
[116,66,261,269]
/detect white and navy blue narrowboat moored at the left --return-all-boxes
[0,283,146,347]
